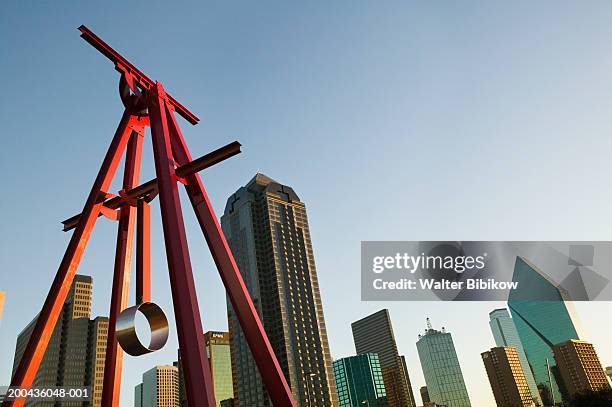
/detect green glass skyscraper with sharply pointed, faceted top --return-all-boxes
[508,257,579,405]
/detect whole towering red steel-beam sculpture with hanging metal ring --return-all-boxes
[2,26,297,407]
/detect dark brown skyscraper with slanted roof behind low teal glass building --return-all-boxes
[351,309,416,407]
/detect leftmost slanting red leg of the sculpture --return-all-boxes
[2,110,131,407]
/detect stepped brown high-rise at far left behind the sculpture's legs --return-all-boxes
[13,274,108,407]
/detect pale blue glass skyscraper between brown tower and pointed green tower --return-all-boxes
[489,308,542,405]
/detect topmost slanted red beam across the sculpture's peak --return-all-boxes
[79,25,200,124]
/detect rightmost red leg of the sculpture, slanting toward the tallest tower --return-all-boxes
[167,104,297,407]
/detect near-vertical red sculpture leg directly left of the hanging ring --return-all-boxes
[102,121,144,407]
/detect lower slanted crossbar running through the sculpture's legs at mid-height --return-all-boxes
[62,141,241,232]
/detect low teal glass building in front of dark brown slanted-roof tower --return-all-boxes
[334,353,387,407]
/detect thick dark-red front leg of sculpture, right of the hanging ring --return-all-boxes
[148,82,216,407]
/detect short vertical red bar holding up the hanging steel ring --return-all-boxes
[136,199,151,304]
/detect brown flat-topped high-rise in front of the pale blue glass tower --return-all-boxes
[481,346,535,407]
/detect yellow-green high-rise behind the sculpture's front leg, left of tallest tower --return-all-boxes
[174,331,234,407]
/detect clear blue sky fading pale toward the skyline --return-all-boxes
[0,1,612,407]
